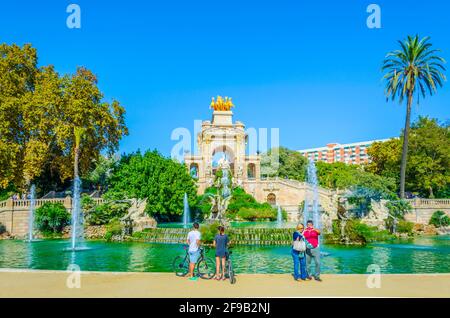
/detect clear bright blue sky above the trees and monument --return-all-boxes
[0,0,450,155]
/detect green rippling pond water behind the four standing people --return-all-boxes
[0,236,450,274]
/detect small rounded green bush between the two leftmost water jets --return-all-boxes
[35,202,70,235]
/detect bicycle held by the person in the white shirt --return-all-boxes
[173,245,216,279]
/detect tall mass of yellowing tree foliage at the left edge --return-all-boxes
[0,44,128,192]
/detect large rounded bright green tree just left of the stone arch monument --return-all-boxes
[106,151,197,220]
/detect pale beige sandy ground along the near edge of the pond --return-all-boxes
[0,269,450,298]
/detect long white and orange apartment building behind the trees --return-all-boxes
[298,139,389,165]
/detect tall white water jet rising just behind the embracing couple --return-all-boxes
[303,159,322,230]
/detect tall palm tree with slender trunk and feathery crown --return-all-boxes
[382,35,446,199]
